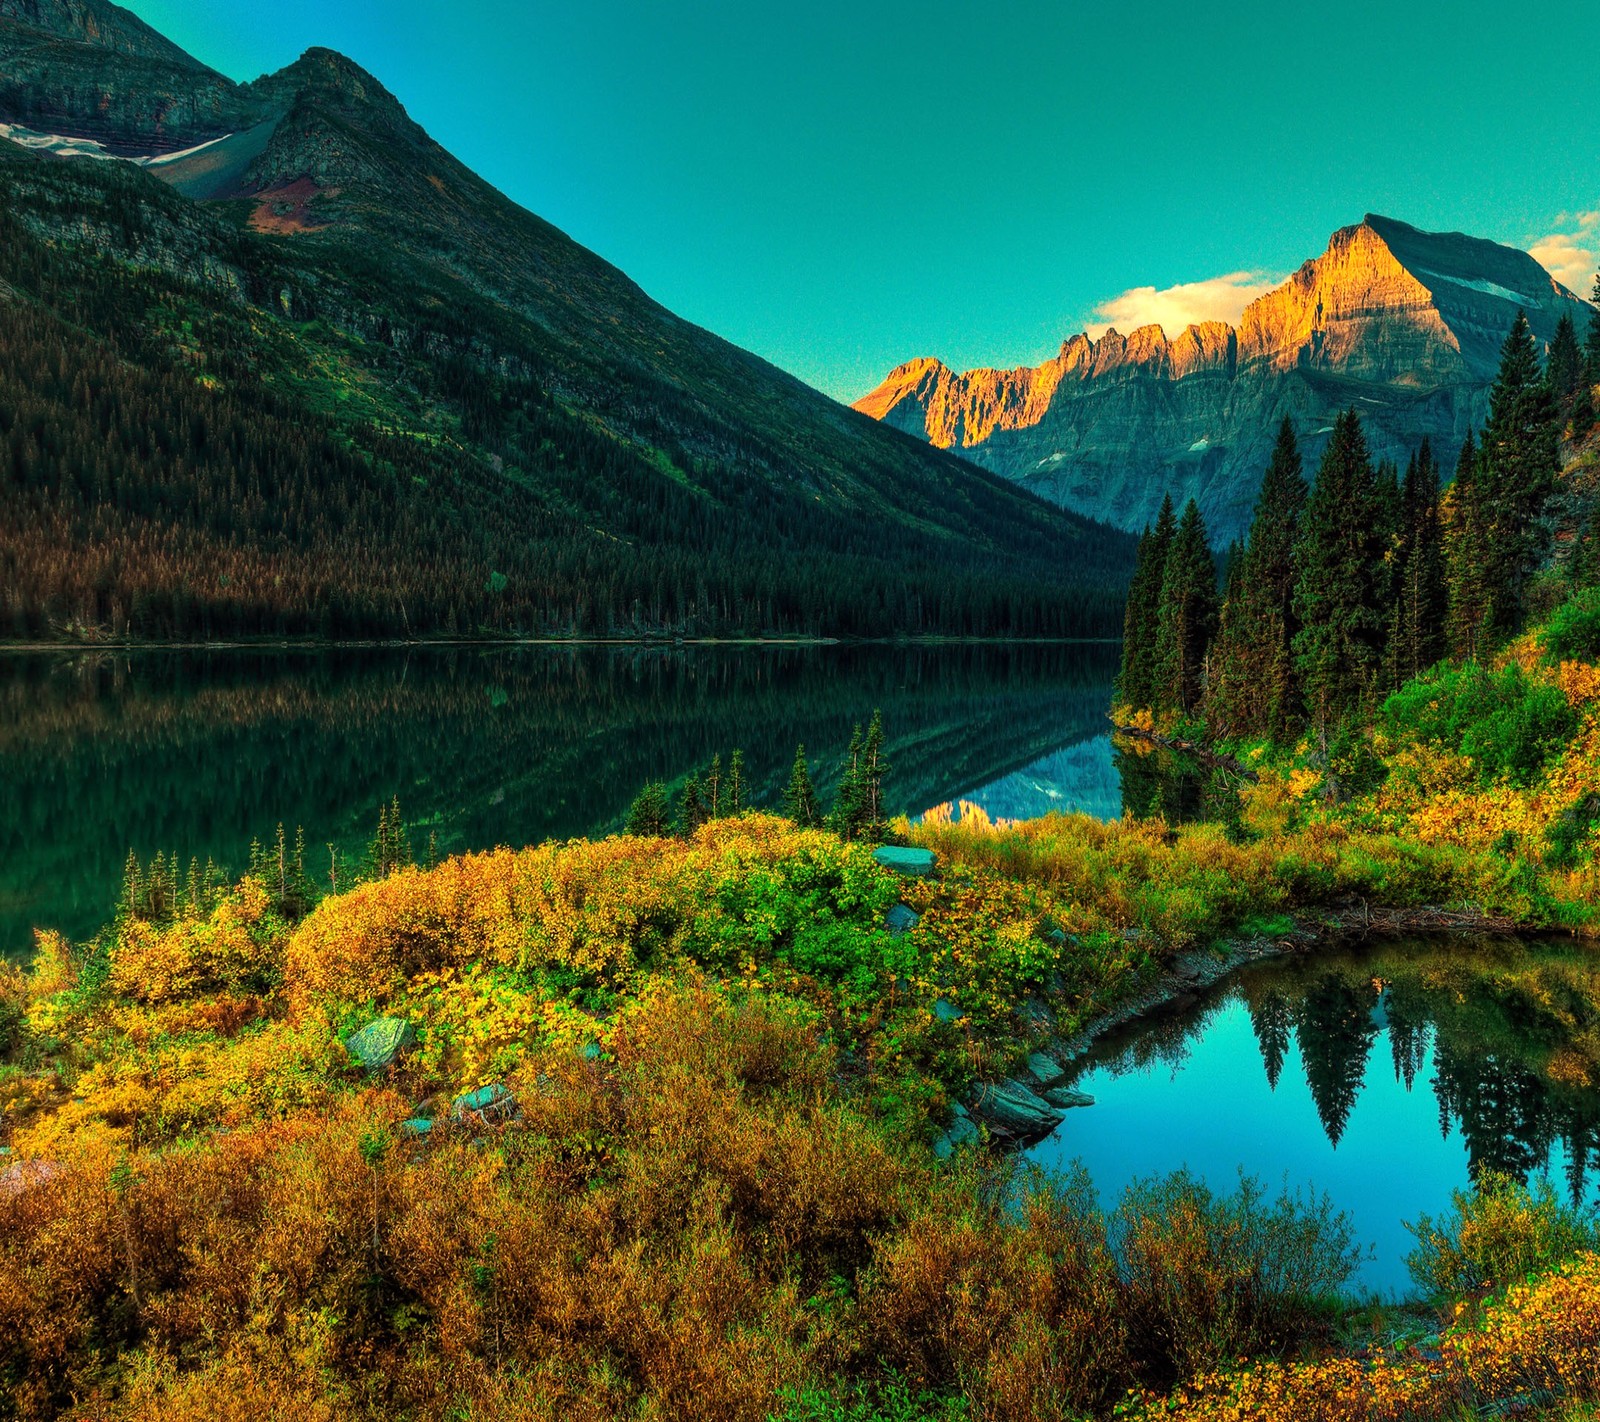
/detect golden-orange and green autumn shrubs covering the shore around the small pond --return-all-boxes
[0,308,1600,1422]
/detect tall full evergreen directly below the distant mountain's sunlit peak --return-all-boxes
[1293,409,1387,734]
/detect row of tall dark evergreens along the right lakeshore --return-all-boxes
[1117,305,1600,741]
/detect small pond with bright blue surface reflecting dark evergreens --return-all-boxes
[1030,939,1600,1297]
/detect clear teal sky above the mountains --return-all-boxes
[131,0,1600,400]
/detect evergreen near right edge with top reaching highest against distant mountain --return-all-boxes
[1478,312,1560,640]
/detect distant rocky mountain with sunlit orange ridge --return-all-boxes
[854,214,1587,542]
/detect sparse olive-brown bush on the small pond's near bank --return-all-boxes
[1114,1171,1362,1377]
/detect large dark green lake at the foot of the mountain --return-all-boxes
[0,645,1142,957]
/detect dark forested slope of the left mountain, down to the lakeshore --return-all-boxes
[0,135,1133,640]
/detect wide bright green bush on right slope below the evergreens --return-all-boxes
[1381,662,1578,785]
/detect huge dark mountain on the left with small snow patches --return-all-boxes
[0,0,1131,637]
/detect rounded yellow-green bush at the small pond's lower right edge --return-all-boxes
[1405,1171,1600,1294]
